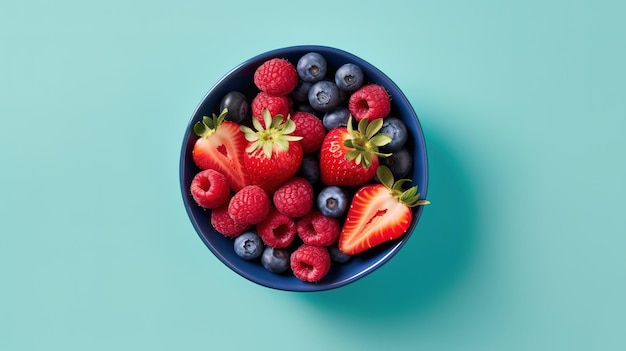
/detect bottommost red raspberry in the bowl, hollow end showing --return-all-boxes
[290,244,331,282]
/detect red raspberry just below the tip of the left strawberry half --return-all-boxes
[228,185,270,225]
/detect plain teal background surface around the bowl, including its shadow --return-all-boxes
[0,0,626,351]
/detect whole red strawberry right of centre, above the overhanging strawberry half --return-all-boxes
[320,117,391,186]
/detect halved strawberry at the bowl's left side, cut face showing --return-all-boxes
[192,109,250,191]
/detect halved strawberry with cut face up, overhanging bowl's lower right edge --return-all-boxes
[338,166,430,255]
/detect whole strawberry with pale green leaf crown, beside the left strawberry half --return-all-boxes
[241,109,303,195]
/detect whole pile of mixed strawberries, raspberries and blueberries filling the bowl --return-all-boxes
[189,52,429,282]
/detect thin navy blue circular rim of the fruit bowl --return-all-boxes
[178,45,429,292]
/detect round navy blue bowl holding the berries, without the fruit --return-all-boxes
[180,45,428,291]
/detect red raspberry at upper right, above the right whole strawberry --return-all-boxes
[348,84,391,121]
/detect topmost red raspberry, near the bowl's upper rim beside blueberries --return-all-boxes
[254,58,299,95]
